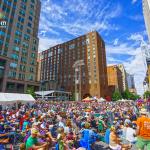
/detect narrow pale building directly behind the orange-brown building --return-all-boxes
[118,64,128,91]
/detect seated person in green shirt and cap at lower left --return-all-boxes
[26,128,48,150]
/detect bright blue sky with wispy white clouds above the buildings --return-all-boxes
[39,0,148,94]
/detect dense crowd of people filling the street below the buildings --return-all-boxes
[0,101,150,150]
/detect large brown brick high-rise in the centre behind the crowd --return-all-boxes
[40,31,107,98]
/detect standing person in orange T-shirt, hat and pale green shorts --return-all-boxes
[136,109,150,150]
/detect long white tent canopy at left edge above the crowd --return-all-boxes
[0,93,35,104]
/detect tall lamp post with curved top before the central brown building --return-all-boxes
[73,60,84,101]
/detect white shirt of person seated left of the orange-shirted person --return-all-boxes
[126,127,136,142]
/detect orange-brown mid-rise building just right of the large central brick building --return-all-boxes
[107,65,124,96]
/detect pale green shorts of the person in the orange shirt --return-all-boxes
[136,137,150,150]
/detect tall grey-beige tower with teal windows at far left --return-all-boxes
[0,0,41,92]
